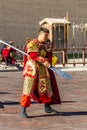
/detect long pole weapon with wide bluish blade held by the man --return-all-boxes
[0,39,72,80]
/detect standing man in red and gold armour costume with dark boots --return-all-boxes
[20,28,61,118]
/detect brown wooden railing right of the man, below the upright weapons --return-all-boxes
[53,48,87,66]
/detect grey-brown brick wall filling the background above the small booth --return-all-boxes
[0,0,87,45]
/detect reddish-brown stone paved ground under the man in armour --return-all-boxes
[0,71,87,130]
